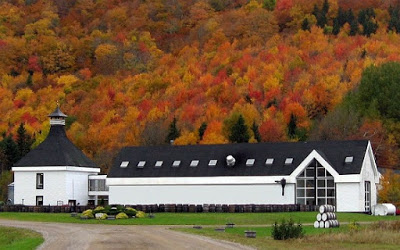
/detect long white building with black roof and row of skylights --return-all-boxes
[106,141,380,212]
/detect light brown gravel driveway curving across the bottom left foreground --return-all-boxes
[0,220,251,250]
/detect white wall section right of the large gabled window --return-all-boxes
[336,182,364,212]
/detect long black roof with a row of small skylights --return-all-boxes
[108,140,368,178]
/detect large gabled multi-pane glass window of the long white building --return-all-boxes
[296,160,335,205]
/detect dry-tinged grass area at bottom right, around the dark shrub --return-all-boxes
[174,221,400,249]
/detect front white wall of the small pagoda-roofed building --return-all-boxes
[14,171,68,206]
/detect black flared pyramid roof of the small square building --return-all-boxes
[14,126,97,168]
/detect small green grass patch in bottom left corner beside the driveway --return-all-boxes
[0,226,43,250]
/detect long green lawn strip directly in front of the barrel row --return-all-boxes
[0,212,400,226]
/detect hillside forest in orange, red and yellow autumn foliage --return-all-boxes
[0,0,400,182]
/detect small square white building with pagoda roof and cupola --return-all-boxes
[12,107,104,206]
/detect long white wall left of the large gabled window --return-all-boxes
[109,184,295,204]
